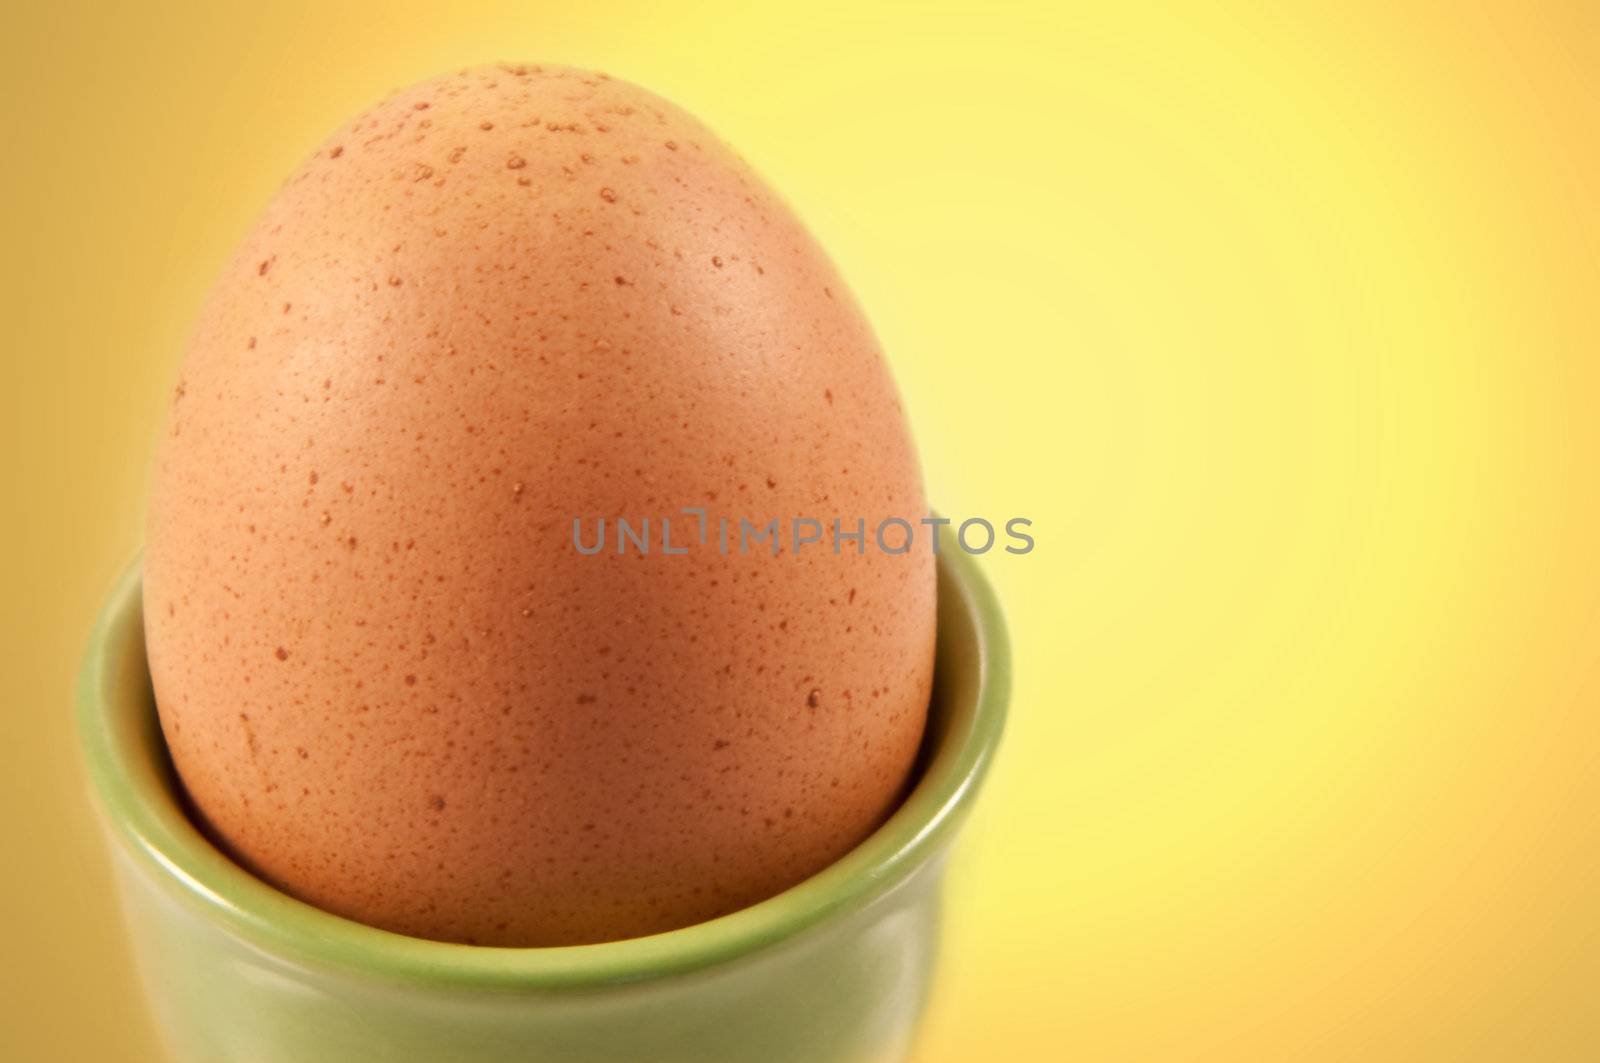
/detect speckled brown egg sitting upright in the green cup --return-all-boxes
[144,66,934,945]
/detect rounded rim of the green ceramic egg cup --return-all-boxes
[77,548,1010,989]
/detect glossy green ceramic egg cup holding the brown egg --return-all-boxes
[77,541,1010,1063]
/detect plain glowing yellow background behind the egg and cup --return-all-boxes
[0,0,1600,1063]
